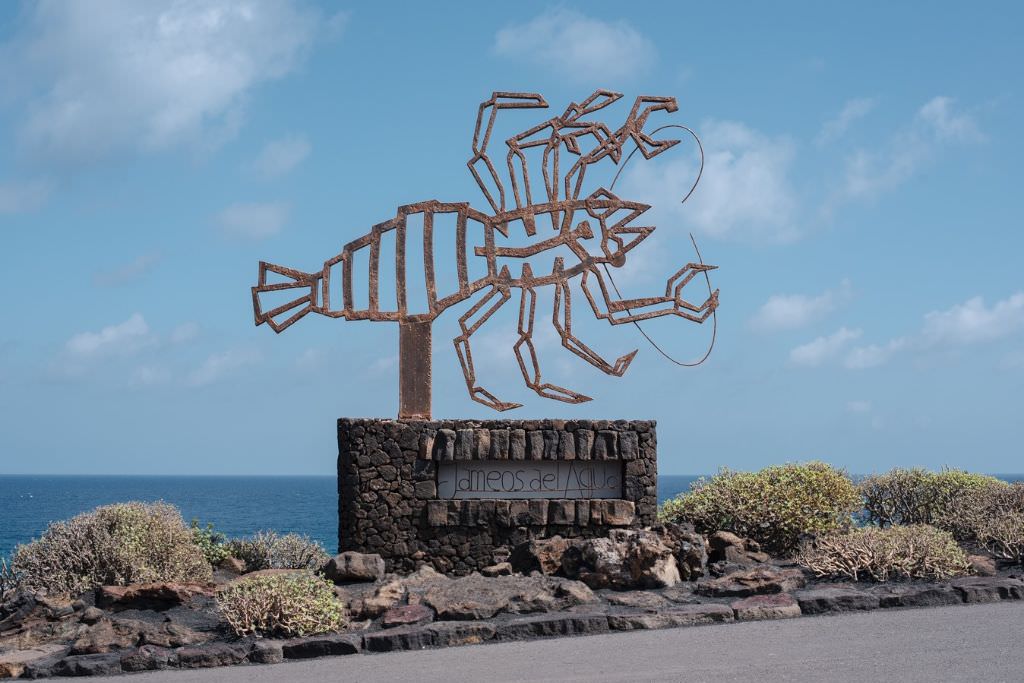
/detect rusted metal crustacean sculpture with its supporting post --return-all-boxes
[252,90,719,418]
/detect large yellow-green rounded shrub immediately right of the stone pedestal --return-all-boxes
[658,462,860,553]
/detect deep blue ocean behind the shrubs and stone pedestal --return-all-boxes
[0,475,697,557]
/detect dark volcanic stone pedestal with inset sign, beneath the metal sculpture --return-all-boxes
[338,418,657,573]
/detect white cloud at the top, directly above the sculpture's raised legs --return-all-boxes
[494,7,656,83]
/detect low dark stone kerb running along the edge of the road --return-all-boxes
[16,577,1024,678]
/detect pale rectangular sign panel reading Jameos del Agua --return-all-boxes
[437,460,623,500]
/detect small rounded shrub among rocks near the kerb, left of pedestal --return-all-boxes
[217,571,345,638]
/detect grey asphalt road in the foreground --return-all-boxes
[93,602,1024,683]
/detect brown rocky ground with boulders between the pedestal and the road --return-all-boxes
[0,526,1024,678]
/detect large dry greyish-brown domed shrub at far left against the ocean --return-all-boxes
[12,502,211,596]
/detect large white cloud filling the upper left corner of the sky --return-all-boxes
[0,0,321,164]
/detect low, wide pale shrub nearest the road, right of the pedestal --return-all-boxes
[797,524,971,582]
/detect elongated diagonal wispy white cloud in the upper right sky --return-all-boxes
[825,97,983,205]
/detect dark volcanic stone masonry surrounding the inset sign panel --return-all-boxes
[336,418,655,583]
